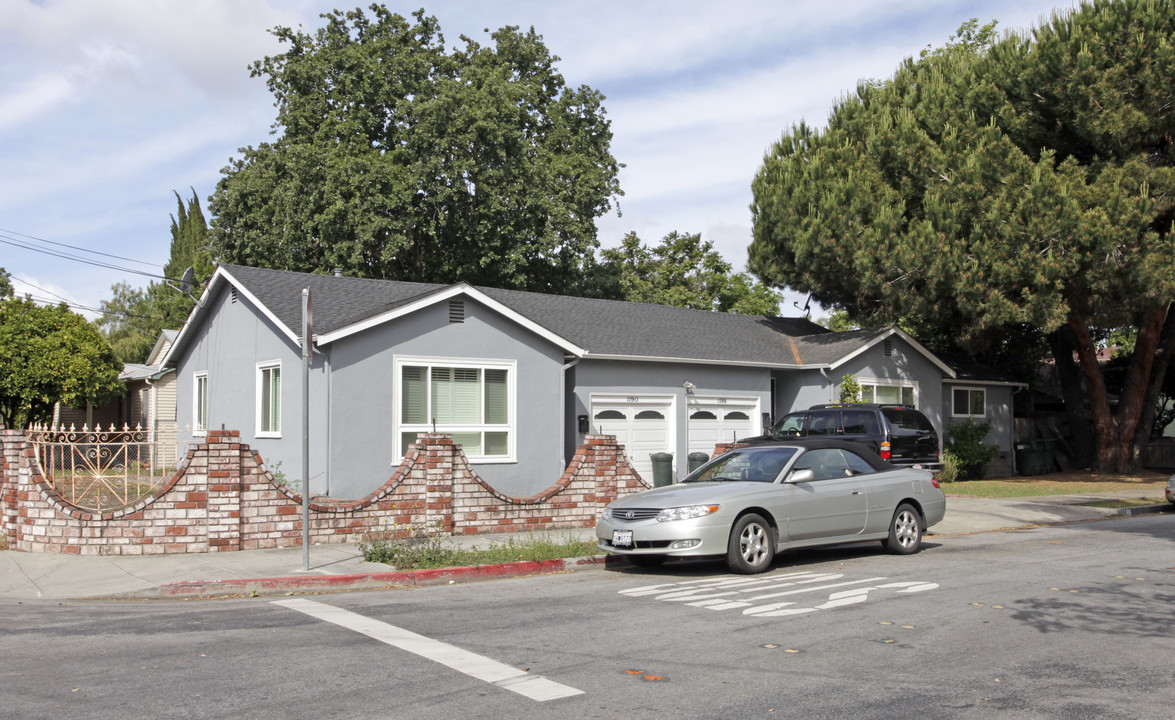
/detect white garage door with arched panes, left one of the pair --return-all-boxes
[591,396,677,483]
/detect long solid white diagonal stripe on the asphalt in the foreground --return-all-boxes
[274,598,584,702]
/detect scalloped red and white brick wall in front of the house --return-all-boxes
[0,430,647,554]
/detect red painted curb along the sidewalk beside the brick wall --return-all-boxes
[159,557,604,598]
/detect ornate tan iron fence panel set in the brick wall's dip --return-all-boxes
[28,425,167,512]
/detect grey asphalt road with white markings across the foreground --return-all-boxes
[0,514,1175,720]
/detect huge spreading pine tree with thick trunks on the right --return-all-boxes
[750,0,1175,471]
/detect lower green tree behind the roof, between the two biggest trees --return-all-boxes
[590,231,779,315]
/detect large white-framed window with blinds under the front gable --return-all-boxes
[396,358,516,462]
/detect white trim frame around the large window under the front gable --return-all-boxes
[391,355,518,465]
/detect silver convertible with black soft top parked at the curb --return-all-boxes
[596,439,946,573]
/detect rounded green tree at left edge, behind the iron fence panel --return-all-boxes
[0,298,123,428]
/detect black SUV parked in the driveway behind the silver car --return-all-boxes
[740,403,942,467]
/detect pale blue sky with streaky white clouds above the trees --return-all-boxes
[0,0,1070,316]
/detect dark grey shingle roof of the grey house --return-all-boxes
[192,264,869,366]
